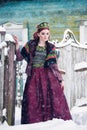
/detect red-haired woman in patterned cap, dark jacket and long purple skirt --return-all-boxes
[14,22,71,124]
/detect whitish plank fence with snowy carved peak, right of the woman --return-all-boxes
[56,30,87,108]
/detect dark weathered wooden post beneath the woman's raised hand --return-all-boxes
[7,42,16,125]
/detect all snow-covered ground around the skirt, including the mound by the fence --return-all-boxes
[0,98,87,130]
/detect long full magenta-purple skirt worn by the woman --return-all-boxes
[21,67,72,124]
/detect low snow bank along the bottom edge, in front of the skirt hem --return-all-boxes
[0,119,87,130]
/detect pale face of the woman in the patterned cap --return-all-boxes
[38,29,50,42]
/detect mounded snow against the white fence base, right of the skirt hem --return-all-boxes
[71,97,87,125]
